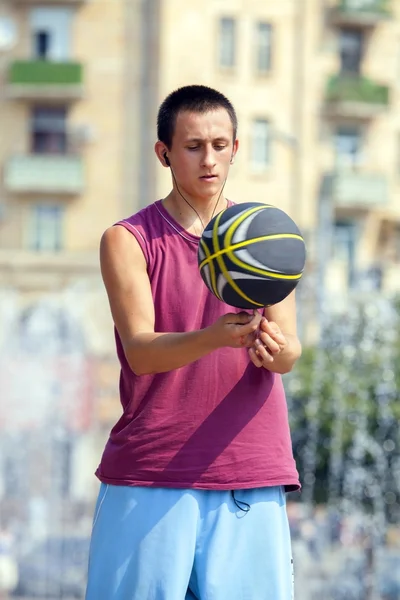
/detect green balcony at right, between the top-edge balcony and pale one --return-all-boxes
[325,74,389,119]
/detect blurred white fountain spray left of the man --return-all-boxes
[0,284,113,598]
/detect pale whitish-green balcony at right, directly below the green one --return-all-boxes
[323,169,389,210]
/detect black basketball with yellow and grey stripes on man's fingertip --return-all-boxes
[198,202,306,309]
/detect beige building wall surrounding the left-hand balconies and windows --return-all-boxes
[0,0,140,252]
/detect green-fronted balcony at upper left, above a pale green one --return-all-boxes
[6,60,83,102]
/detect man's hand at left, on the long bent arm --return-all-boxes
[209,312,262,348]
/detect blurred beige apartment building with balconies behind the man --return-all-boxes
[0,0,400,300]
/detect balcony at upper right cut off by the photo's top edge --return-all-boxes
[330,0,392,27]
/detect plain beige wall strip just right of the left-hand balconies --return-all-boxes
[66,0,125,250]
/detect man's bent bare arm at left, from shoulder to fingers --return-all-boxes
[100,226,259,375]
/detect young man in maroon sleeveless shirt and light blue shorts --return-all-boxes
[86,86,301,600]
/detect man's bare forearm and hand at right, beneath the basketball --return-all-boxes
[249,292,301,374]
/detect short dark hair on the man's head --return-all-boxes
[157,85,238,149]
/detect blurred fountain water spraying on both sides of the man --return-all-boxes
[0,282,400,600]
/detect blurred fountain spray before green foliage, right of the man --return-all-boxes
[287,294,400,600]
